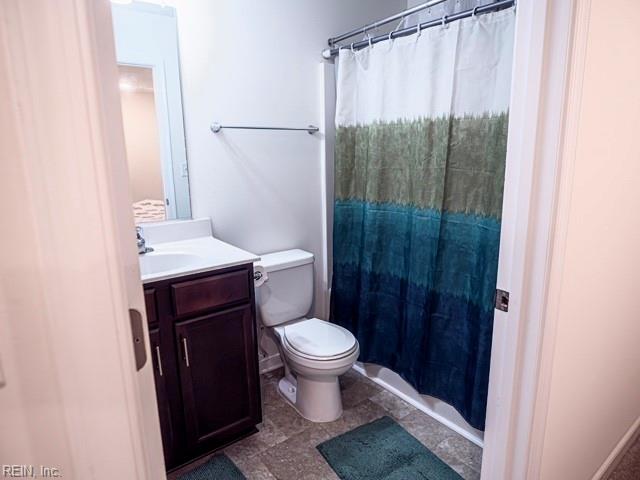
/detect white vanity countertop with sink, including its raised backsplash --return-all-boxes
[139,219,260,283]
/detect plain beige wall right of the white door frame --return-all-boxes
[538,0,640,480]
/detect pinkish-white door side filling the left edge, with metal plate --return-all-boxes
[0,0,165,480]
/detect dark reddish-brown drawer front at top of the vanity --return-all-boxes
[171,270,250,315]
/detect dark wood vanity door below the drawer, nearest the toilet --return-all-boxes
[175,305,261,450]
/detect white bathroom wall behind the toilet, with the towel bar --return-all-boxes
[170,0,406,316]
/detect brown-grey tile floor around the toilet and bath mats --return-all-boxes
[169,370,482,480]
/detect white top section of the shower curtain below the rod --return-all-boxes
[336,8,515,126]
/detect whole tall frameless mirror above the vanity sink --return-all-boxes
[112,3,191,223]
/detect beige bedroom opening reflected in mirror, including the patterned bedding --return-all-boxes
[118,65,166,223]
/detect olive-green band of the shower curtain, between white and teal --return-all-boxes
[335,113,508,219]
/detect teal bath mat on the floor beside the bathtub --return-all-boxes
[317,417,462,480]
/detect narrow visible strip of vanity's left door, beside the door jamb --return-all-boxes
[149,328,174,467]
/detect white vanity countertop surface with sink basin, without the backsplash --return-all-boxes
[139,237,260,283]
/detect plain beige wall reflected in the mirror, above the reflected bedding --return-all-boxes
[121,91,164,202]
